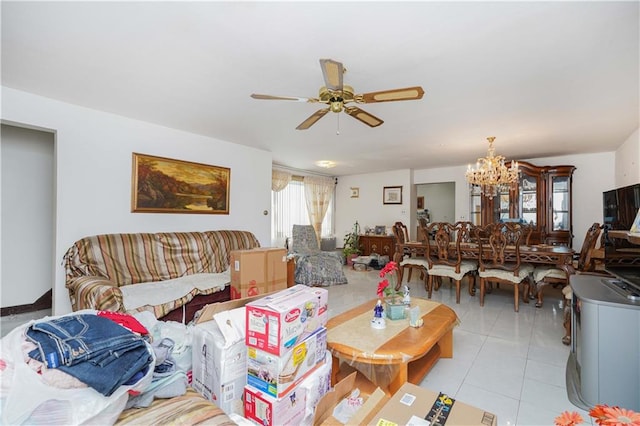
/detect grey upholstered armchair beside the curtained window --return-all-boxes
[290,225,347,287]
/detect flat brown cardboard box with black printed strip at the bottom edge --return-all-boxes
[369,383,498,426]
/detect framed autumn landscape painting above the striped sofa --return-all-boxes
[131,152,231,214]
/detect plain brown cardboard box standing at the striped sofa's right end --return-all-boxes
[230,247,287,299]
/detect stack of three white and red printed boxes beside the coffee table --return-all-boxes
[244,285,328,426]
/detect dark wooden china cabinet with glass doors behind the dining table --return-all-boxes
[469,161,576,246]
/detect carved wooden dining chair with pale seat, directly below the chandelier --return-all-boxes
[474,223,533,312]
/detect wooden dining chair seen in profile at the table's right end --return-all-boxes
[530,222,602,308]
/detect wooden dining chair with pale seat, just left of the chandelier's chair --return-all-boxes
[426,222,478,304]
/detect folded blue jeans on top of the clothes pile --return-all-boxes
[26,314,153,396]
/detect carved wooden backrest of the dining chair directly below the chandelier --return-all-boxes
[474,223,524,275]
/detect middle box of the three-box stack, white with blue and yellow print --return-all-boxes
[247,327,327,398]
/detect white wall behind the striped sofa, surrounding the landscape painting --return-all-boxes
[2,87,272,315]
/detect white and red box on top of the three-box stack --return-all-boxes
[246,284,329,355]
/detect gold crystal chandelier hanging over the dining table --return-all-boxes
[466,136,519,199]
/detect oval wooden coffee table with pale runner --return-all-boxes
[327,297,458,394]
